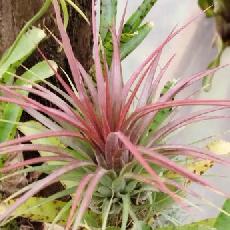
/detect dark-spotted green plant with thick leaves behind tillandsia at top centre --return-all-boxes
[100,0,157,64]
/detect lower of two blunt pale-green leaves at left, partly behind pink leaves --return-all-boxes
[0,61,57,142]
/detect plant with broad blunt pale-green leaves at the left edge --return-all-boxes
[0,27,57,171]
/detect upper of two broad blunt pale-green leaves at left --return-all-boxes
[0,27,46,79]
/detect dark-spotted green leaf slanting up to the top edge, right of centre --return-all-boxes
[122,0,157,33]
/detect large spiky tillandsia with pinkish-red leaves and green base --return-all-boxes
[0,0,230,230]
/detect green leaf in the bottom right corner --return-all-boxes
[214,199,230,230]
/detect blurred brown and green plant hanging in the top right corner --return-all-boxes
[198,0,230,91]
